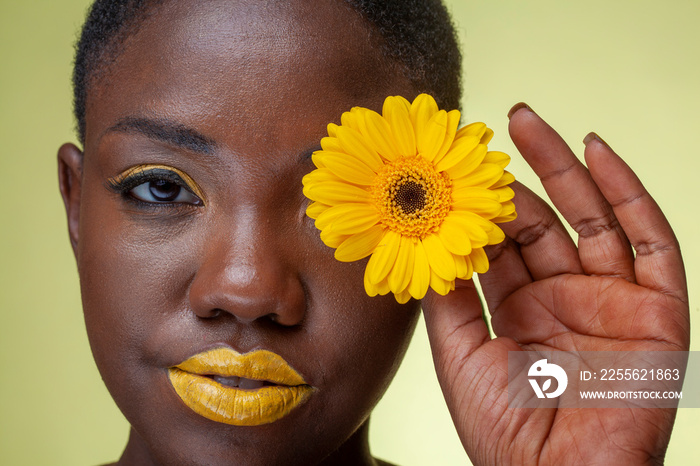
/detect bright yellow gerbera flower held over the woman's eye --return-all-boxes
[303,94,516,303]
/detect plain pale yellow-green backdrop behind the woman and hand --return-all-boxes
[0,0,700,465]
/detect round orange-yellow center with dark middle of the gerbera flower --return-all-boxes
[372,155,452,238]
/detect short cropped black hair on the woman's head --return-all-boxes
[73,0,462,143]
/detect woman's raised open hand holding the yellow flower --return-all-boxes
[423,106,690,465]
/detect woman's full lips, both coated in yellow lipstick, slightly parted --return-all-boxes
[168,348,314,426]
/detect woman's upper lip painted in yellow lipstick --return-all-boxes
[175,347,306,386]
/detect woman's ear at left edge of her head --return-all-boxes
[58,143,83,256]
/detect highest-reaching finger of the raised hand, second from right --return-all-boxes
[509,106,635,282]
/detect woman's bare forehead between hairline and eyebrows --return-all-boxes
[86,0,410,157]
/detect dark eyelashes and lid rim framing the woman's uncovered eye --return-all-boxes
[107,166,204,207]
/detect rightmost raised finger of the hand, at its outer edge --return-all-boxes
[585,133,688,304]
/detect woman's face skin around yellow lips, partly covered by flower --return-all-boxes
[59,0,418,465]
